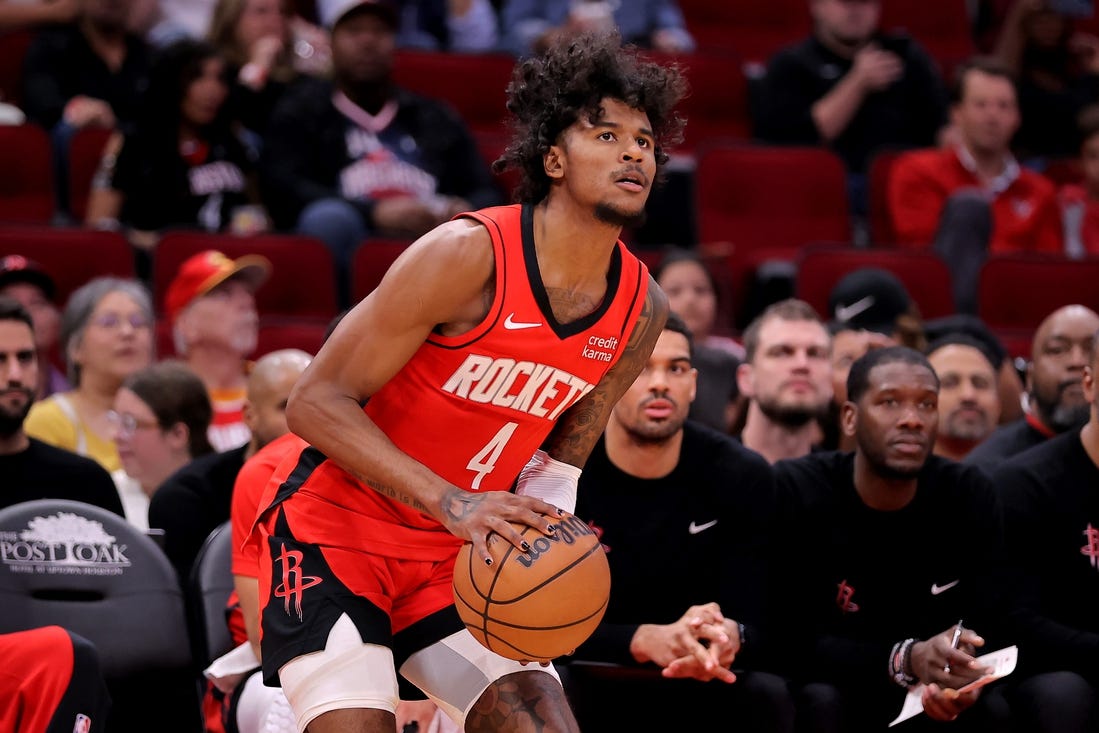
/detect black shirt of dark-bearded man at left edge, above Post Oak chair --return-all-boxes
[0,437,125,517]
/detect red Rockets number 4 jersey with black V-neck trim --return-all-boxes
[271,206,648,559]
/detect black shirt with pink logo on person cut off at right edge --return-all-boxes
[992,430,1099,678]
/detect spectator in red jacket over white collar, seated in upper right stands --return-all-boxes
[888,58,1063,313]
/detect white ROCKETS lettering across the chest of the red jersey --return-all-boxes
[443,354,595,420]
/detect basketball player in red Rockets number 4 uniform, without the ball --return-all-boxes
[257,27,684,733]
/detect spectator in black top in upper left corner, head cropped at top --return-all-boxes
[22,0,149,218]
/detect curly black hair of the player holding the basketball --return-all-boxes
[492,32,687,203]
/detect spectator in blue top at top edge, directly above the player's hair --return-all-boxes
[500,0,695,56]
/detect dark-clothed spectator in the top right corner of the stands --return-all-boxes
[995,0,1099,163]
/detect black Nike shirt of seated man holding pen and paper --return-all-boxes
[775,452,1002,698]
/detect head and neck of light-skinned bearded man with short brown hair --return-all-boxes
[736,299,832,463]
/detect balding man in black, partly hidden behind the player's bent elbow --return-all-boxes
[148,348,312,584]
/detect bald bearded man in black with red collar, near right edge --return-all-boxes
[965,304,1099,473]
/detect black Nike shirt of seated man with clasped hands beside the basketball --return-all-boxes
[575,421,774,667]
